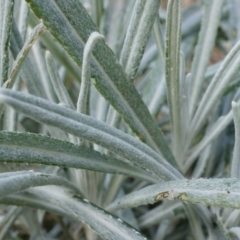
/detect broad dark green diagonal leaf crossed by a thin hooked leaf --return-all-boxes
[27,0,176,165]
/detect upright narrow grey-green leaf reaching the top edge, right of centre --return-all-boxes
[165,0,181,157]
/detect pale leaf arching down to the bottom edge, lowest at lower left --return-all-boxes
[0,186,147,240]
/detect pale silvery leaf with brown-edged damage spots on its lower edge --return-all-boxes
[107,178,240,211]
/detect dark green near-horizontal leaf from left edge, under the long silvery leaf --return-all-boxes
[0,132,156,182]
